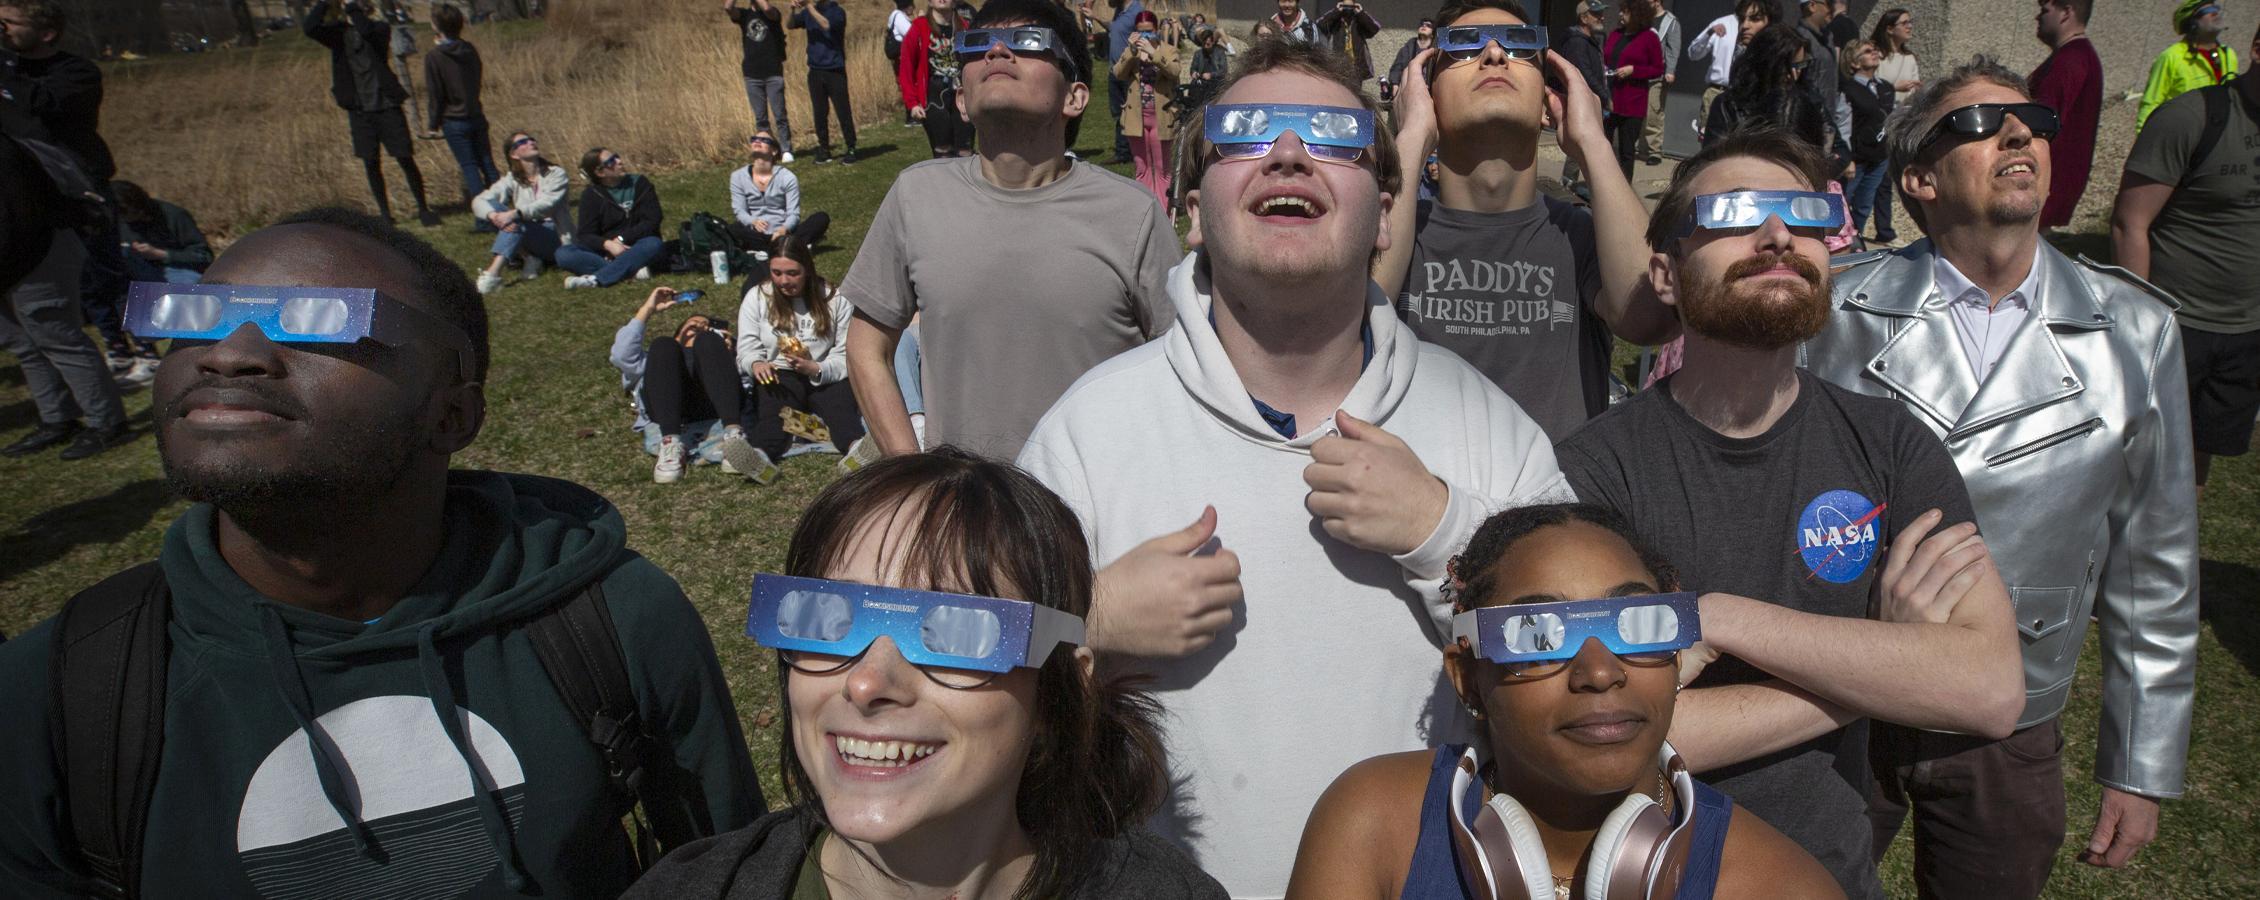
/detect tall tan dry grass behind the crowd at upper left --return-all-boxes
[102,0,902,237]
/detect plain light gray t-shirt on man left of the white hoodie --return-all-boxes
[841,156,1182,461]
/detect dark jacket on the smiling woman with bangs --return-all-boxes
[619,807,1225,900]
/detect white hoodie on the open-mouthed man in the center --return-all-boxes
[1019,251,1573,898]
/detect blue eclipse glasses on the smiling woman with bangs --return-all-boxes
[746,574,1083,690]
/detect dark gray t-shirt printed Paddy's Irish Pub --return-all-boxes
[1397,194,1611,441]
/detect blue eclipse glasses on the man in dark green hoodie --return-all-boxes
[127,280,479,382]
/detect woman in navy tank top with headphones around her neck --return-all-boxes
[1286,504,1844,900]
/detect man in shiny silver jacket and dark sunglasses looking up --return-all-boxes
[1806,57,2187,898]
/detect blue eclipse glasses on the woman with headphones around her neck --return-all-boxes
[1451,590,1702,678]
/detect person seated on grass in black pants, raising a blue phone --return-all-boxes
[612,287,775,484]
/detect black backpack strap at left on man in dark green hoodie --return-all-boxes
[47,563,172,900]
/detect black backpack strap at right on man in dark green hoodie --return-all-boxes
[527,579,698,868]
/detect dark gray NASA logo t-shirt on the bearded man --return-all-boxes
[1555,369,1978,900]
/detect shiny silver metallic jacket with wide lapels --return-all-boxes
[1799,240,2197,798]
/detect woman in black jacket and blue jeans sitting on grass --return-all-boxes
[556,147,667,287]
